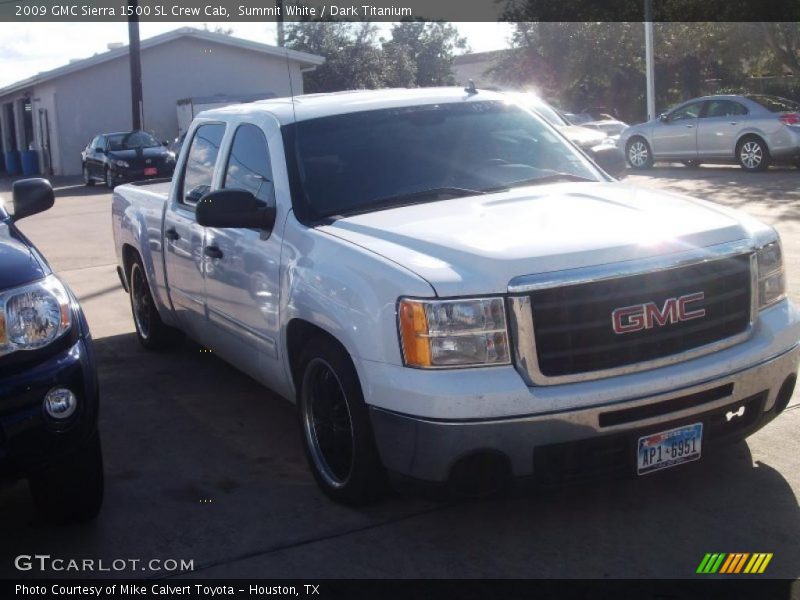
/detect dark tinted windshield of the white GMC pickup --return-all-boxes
[283,101,602,220]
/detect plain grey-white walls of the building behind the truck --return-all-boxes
[12,38,303,175]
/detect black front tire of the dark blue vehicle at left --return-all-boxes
[28,431,104,524]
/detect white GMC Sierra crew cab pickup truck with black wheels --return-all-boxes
[112,88,800,504]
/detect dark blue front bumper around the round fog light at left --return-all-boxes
[0,335,98,478]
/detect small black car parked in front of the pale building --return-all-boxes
[81,131,175,189]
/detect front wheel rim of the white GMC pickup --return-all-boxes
[302,358,355,488]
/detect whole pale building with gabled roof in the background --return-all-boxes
[0,28,325,175]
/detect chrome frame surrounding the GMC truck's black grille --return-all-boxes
[507,241,759,386]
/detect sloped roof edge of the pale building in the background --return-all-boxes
[0,27,325,96]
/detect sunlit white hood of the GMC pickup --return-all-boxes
[320,182,765,296]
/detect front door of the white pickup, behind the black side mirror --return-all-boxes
[205,123,286,383]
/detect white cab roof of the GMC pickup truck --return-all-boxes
[198,87,508,125]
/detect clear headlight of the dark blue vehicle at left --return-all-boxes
[0,275,72,356]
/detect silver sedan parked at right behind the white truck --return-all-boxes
[620,94,800,171]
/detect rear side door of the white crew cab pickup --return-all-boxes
[163,123,225,343]
